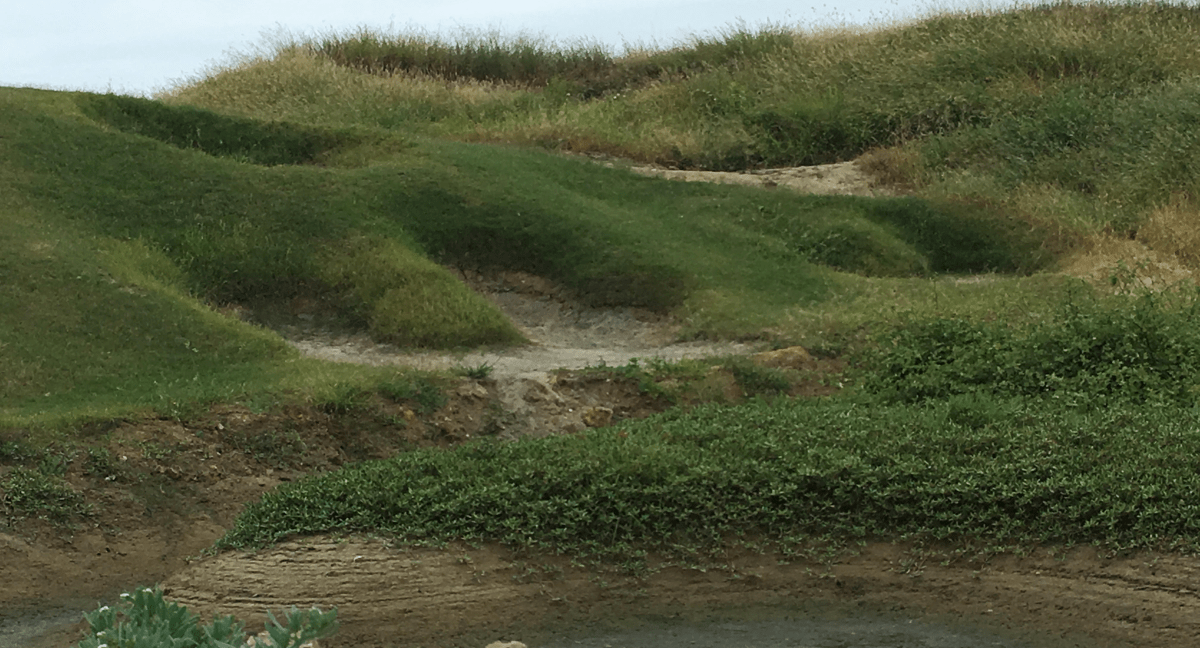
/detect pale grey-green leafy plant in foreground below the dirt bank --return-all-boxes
[77,588,337,648]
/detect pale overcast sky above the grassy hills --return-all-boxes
[0,0,978,95]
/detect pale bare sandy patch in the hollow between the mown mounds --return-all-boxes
[280,265,755,438]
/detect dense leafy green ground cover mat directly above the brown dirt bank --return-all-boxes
[217,394,1200,557]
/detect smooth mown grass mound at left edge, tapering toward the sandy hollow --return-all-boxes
[0,198,294,418]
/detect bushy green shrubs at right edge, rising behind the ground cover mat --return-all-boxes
[863,280,1200,407]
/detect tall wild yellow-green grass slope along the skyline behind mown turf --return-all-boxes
[166,2,1200,246]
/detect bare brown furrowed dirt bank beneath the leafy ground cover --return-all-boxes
[157,538,1200,648]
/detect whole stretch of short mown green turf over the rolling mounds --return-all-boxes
[0,83,1046,415]
